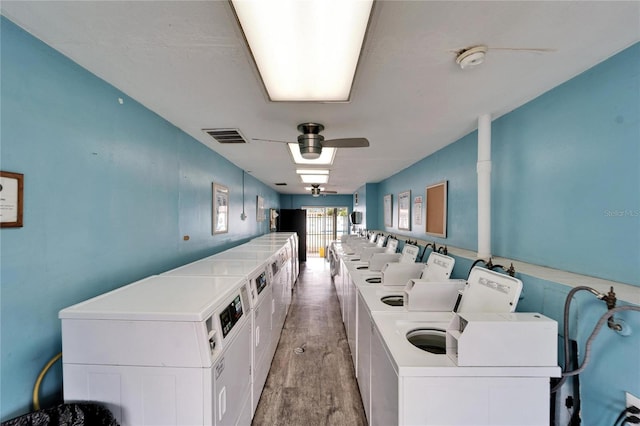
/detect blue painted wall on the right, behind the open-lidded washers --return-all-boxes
[367,44,640,425]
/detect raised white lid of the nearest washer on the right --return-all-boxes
[457,266,522,313]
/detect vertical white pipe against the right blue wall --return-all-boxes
[477,114,491,260]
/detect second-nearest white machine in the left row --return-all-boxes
[163,259,277,417]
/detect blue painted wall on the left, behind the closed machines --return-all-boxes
[0,17,280,420]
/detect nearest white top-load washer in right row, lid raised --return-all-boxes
[369,267,560,426]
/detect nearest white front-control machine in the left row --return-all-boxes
[59,276,251,426]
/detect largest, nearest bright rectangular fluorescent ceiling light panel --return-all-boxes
[231,0,373,102]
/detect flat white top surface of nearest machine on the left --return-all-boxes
[59,275,247,322]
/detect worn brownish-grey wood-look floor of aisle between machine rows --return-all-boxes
[253,258,367,426]
